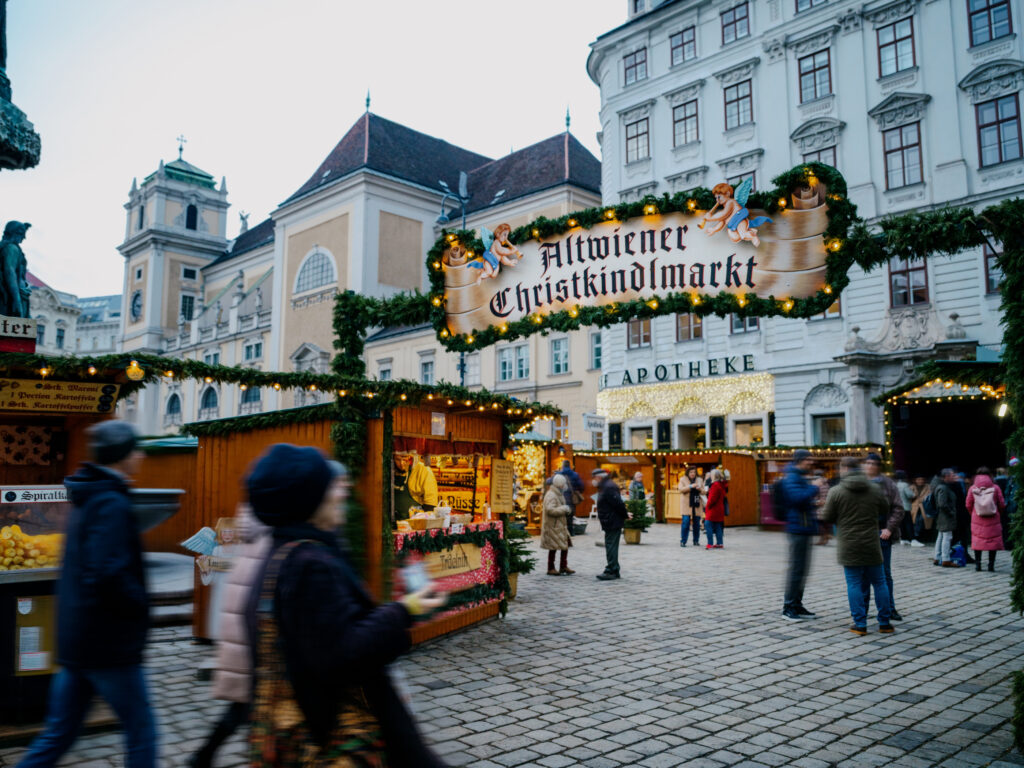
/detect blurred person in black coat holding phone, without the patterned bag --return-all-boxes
[247,444,444,768]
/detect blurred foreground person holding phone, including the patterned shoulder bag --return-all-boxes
[246,444,445,768]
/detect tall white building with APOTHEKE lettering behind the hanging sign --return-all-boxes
[588,0,1024,456]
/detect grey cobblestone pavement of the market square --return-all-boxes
[0,522,1024,768]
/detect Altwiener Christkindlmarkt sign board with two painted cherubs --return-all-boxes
[432,174,846,339]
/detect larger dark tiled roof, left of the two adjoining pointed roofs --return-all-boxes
[285,112,490,203]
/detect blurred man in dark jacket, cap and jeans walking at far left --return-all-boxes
[18,421,157,768]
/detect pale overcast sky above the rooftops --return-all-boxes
[0,0,614,296]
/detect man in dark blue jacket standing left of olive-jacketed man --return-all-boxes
[780,449,824,622]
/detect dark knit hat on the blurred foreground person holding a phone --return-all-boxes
[246,442,338,526]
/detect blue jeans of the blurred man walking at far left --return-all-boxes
[17,666,157,768]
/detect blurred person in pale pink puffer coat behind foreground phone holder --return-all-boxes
[189,504,271,768]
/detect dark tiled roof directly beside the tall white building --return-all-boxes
[462,132,601,214]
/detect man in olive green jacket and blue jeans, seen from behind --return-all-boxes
[822,457,893,635]
